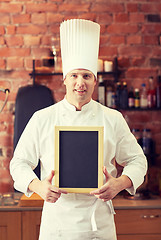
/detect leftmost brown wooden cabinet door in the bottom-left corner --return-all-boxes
[0,212,22,240]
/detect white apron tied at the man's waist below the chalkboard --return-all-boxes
[39,193,116,240]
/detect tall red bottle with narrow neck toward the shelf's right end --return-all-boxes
[148,77,156,108]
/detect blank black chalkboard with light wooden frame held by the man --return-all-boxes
[55,126,103,193]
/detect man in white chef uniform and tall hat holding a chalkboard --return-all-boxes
[10,19,147,240]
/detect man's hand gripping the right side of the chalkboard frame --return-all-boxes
[90,167,132,202]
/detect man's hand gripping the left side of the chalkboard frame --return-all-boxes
[29,171,67,203]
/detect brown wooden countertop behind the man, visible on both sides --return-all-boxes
[0,194,161,211]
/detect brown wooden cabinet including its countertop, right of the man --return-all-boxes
[113,198,161,240]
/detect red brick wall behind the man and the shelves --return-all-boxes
[0,0,161,191]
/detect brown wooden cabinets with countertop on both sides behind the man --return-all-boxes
[0,196,161,240]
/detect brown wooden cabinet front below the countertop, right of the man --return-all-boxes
[115,200,161,240]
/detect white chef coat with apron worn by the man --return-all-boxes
[10,98,147,240]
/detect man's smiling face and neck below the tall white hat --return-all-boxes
[64,69,96,110]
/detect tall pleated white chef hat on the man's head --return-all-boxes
[60,19,100,78]
